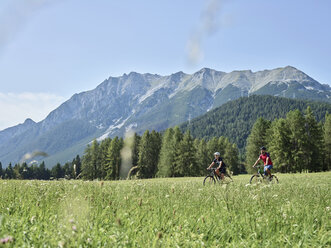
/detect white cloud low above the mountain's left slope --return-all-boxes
[0,92,65,130]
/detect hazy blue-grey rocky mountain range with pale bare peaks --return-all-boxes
[0,66,331,166]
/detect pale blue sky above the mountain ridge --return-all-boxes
[0,0,331,130]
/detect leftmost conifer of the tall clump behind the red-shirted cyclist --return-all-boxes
[246,118,271,172]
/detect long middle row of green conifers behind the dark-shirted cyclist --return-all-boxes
[82,127,240,180]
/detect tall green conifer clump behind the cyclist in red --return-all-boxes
[246,107,331,173]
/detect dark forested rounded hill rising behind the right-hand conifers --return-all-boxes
[180,95,331,151]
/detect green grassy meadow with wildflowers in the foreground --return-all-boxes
[0,172,331,247]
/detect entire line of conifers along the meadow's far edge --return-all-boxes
[0,104,331,180]
